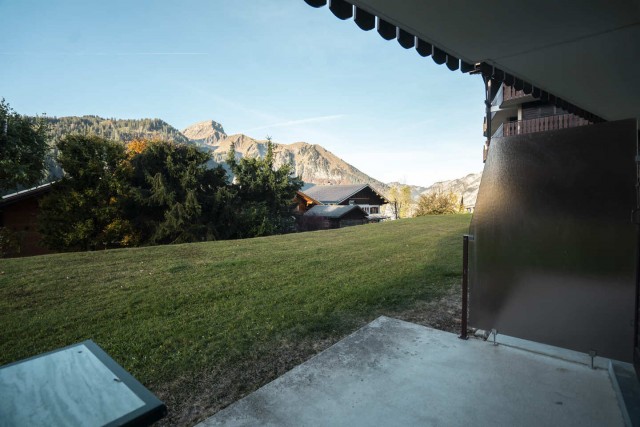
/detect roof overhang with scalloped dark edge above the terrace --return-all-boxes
[306,0,640,120]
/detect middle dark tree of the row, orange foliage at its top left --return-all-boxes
[127,140,233,244]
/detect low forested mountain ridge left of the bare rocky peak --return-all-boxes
[47,116,189,144]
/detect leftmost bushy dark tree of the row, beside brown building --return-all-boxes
[39,135,138,250]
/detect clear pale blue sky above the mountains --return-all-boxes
[0,0,484,185]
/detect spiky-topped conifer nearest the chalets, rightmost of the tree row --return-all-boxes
[226,137,302,237]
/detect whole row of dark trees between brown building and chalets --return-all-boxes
[39,135,302,250]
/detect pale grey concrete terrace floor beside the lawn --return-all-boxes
[199,317,625,427]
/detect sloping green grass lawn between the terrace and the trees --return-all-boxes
[0,215,471,424]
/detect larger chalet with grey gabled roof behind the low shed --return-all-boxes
[302,184,389,215]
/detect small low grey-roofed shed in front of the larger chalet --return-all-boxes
[302,205,368,231]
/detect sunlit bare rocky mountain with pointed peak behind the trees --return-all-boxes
[182,120,388,193]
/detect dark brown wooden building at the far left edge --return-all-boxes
[0,183,51,257]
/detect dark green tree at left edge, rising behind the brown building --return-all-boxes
[0,99,49,193]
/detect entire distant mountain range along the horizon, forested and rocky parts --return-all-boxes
[43,116,481,206]
